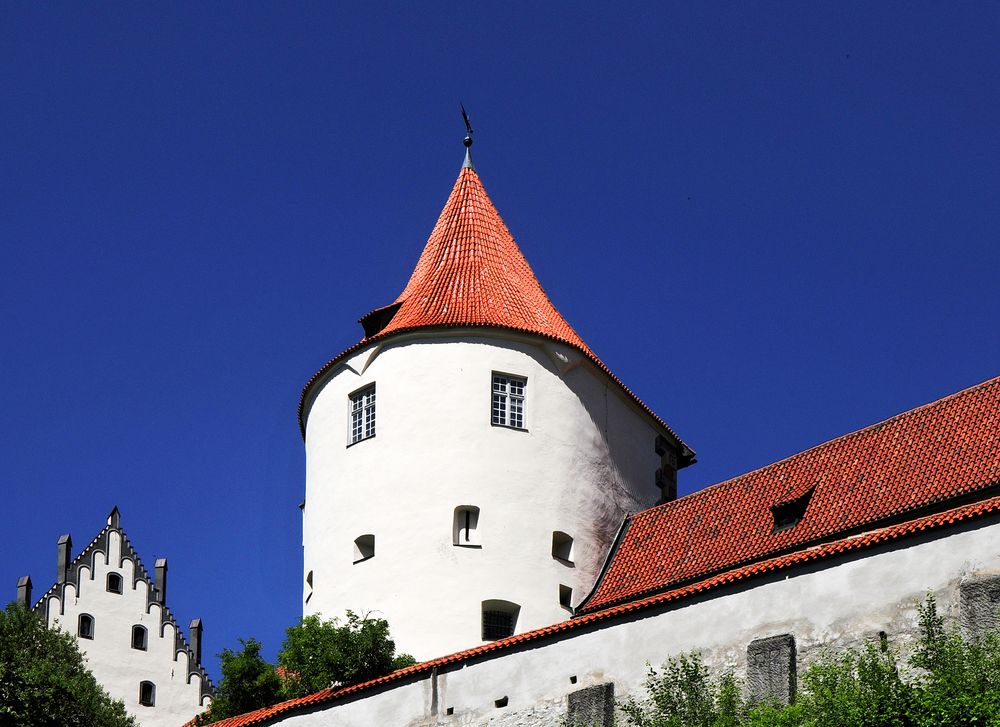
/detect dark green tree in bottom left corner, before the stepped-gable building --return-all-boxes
[0,603,135,727]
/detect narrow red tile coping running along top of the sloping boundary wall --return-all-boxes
[186,496,1000,727]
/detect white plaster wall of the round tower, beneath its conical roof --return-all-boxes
[303,331,661,659]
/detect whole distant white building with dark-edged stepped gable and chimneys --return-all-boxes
[17,507,213,727]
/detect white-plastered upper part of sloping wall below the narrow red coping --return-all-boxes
[280,518,1000,727]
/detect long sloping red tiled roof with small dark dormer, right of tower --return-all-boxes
[578,378,1000,613]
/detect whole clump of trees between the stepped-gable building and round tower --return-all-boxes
[195,611,416,727]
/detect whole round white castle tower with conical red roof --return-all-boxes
[299,139,694,659]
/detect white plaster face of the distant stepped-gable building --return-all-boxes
[47,531,209,727]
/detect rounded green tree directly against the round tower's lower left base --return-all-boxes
[278,611,416,698]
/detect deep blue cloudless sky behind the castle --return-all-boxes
[0,2,1000,676]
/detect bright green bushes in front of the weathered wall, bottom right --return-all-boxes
[619,595,1000,727]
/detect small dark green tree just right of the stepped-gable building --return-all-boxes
[199,638,281,724]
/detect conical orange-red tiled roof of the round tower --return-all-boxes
[299,167,694,458]
